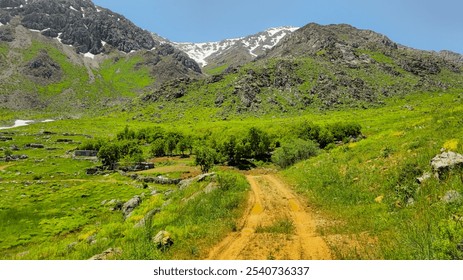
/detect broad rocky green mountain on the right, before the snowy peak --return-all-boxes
[142,23,463,118]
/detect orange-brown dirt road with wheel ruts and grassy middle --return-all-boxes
[209,174,331,260]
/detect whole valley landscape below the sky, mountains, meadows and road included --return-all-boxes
[0,0,463,260]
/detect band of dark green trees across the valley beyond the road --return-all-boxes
[79,122,361,172]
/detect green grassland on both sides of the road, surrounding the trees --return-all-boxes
[0,90,463,259]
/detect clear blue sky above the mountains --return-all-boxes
[93,0,463,54]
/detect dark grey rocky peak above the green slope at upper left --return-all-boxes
[0,0,157,54]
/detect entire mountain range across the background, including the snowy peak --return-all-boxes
[0,0,463,118]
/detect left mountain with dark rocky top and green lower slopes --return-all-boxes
[0,0,202,111]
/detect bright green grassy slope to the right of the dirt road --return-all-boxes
[284,91,463,259]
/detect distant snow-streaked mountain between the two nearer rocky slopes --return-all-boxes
[173,27,297,68]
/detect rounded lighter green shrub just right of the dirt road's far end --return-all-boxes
[272,139,318,168]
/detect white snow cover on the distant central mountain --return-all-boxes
[172,26,298,67]
